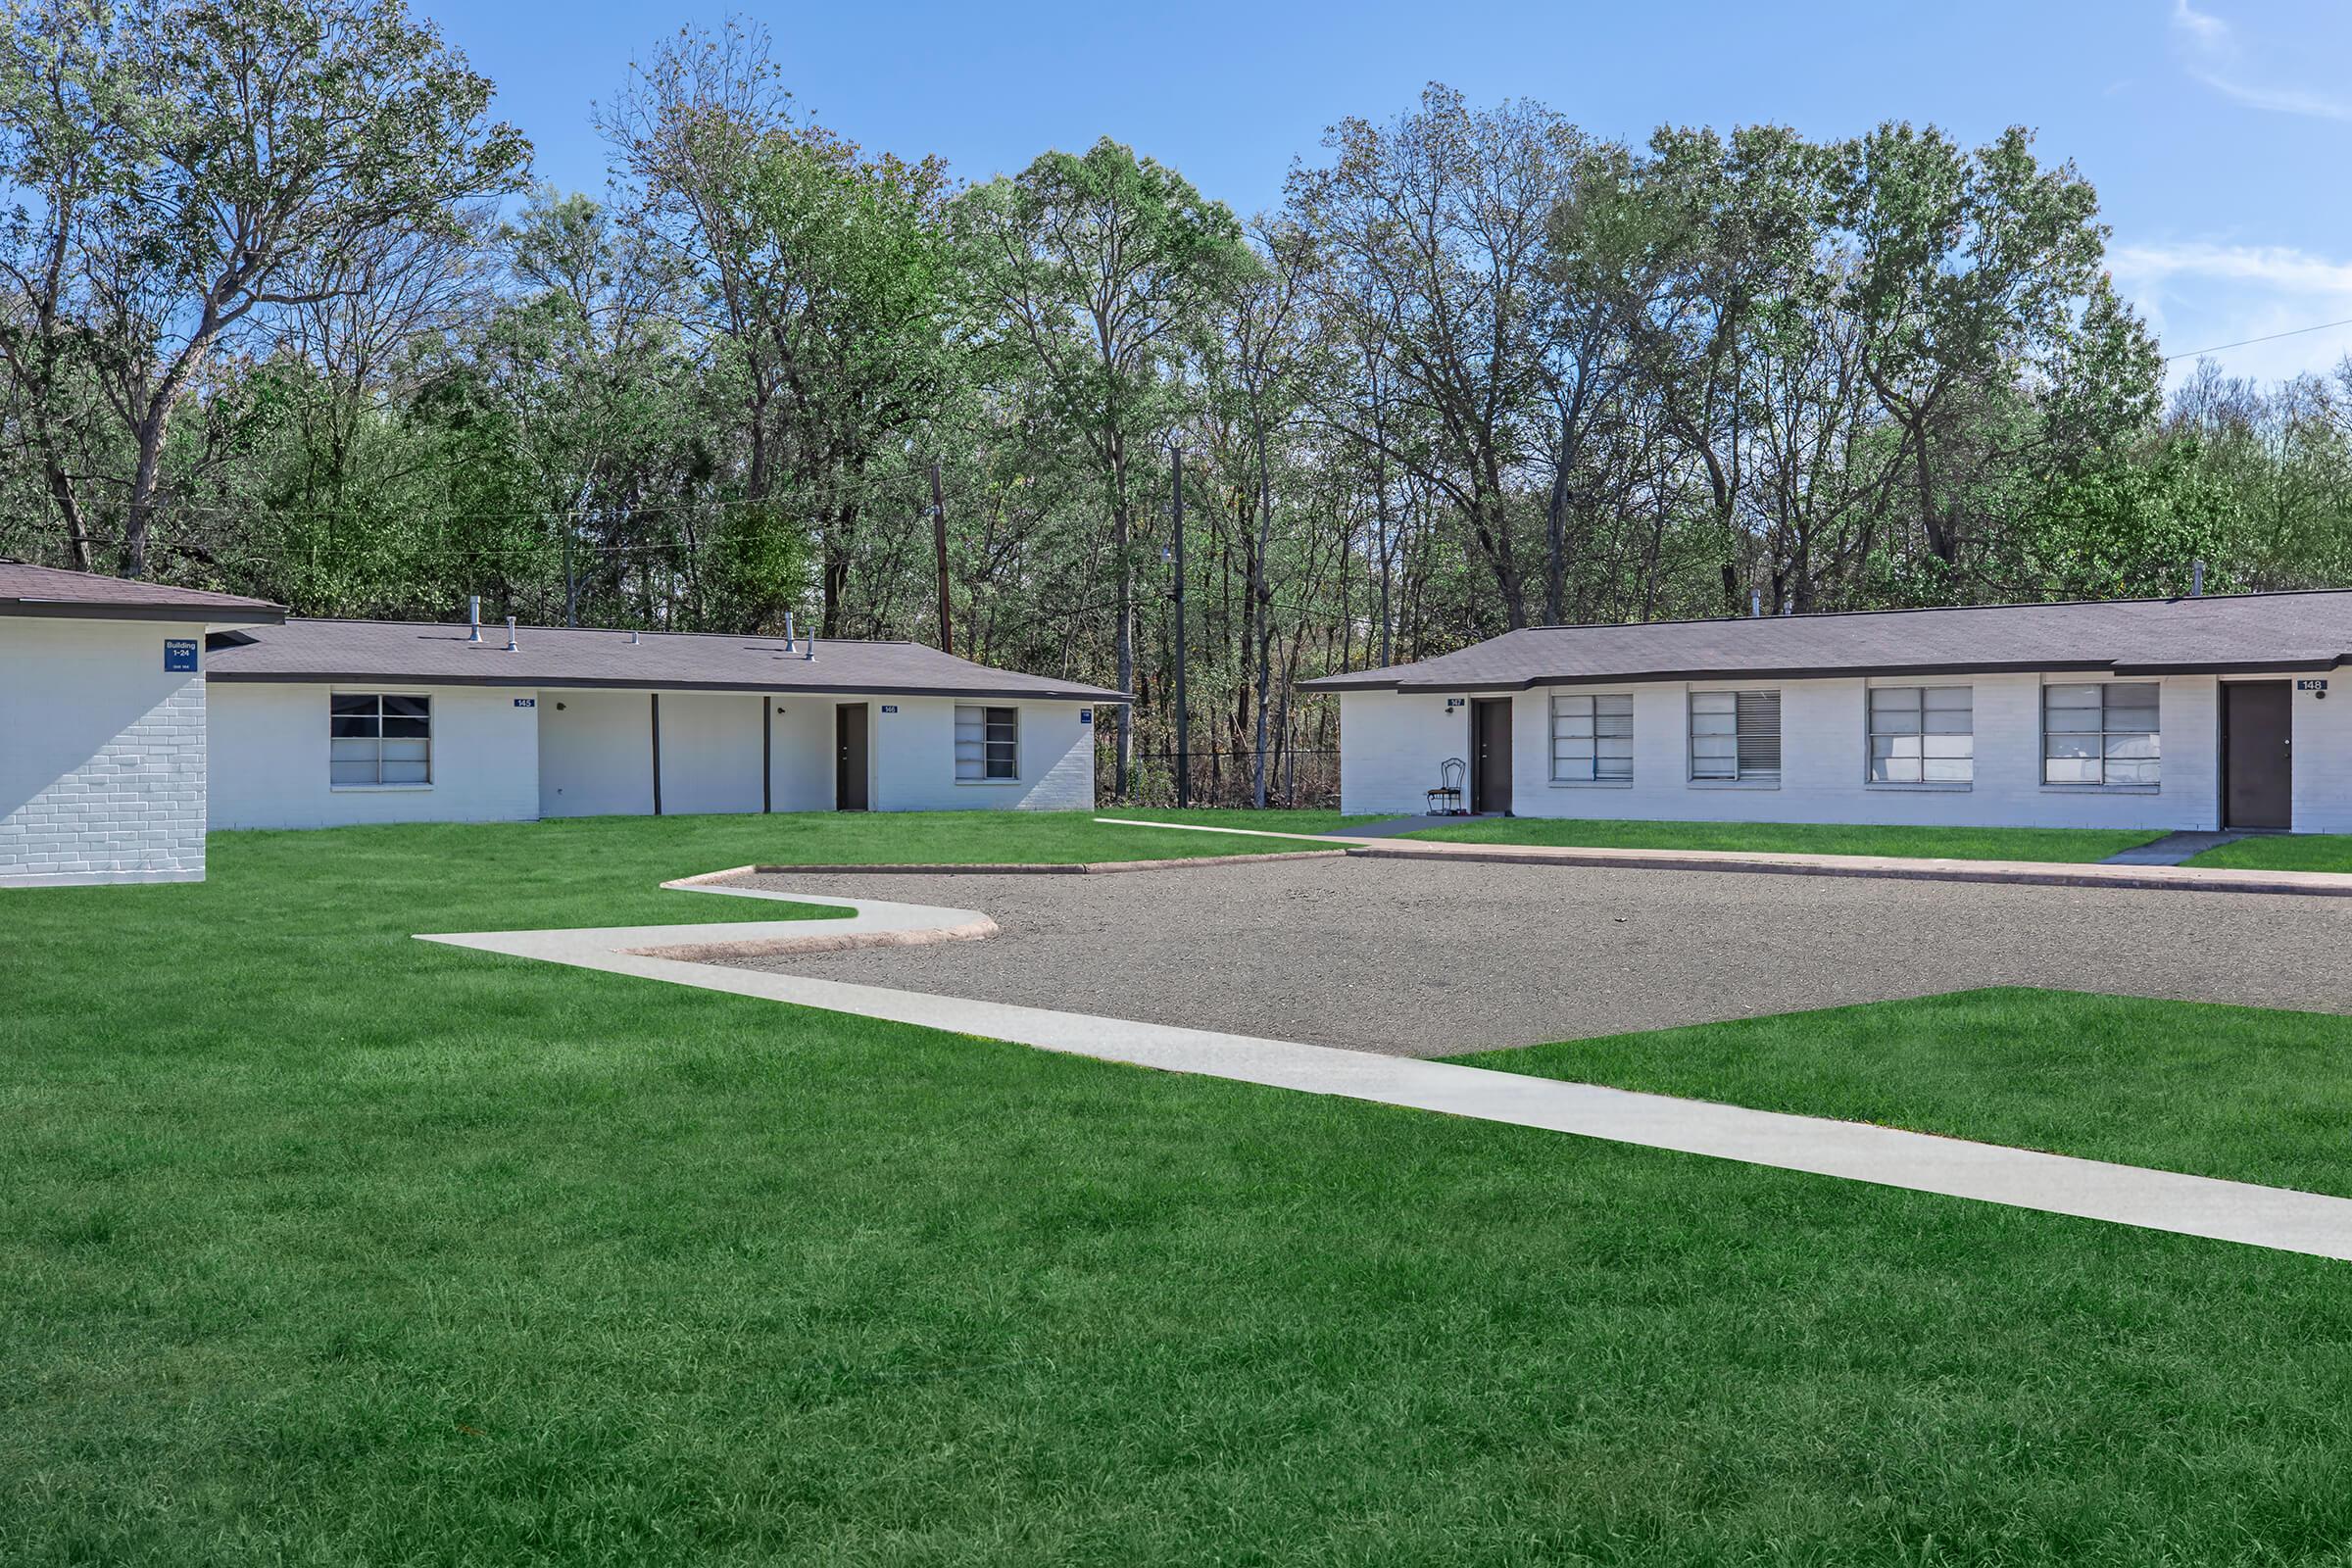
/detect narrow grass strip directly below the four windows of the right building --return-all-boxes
[1404,815,2164,860]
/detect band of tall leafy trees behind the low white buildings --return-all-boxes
[0,39,2352,802]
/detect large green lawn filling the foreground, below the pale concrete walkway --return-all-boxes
[0,815,2352,1568]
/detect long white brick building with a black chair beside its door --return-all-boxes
[1305,592,2352,832]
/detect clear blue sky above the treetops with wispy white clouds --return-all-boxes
[412,0,2352,390]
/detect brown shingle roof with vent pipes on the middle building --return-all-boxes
[205,620,1127,703]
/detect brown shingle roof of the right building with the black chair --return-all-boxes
[1300,588,2352,691]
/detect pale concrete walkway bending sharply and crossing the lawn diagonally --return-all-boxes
[418,872,2352,1260]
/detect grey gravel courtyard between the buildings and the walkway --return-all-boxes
[710,860,2352,1055]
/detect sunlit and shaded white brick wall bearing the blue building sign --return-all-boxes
[0,618,205,886]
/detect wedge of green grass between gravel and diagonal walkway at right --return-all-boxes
[1456,987,2352,1197]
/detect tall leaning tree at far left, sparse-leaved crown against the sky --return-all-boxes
[0,0,529,576]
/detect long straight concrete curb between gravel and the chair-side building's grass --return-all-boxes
[1346,842,2352,898]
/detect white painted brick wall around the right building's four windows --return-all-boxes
[1341,674,2277,830]
